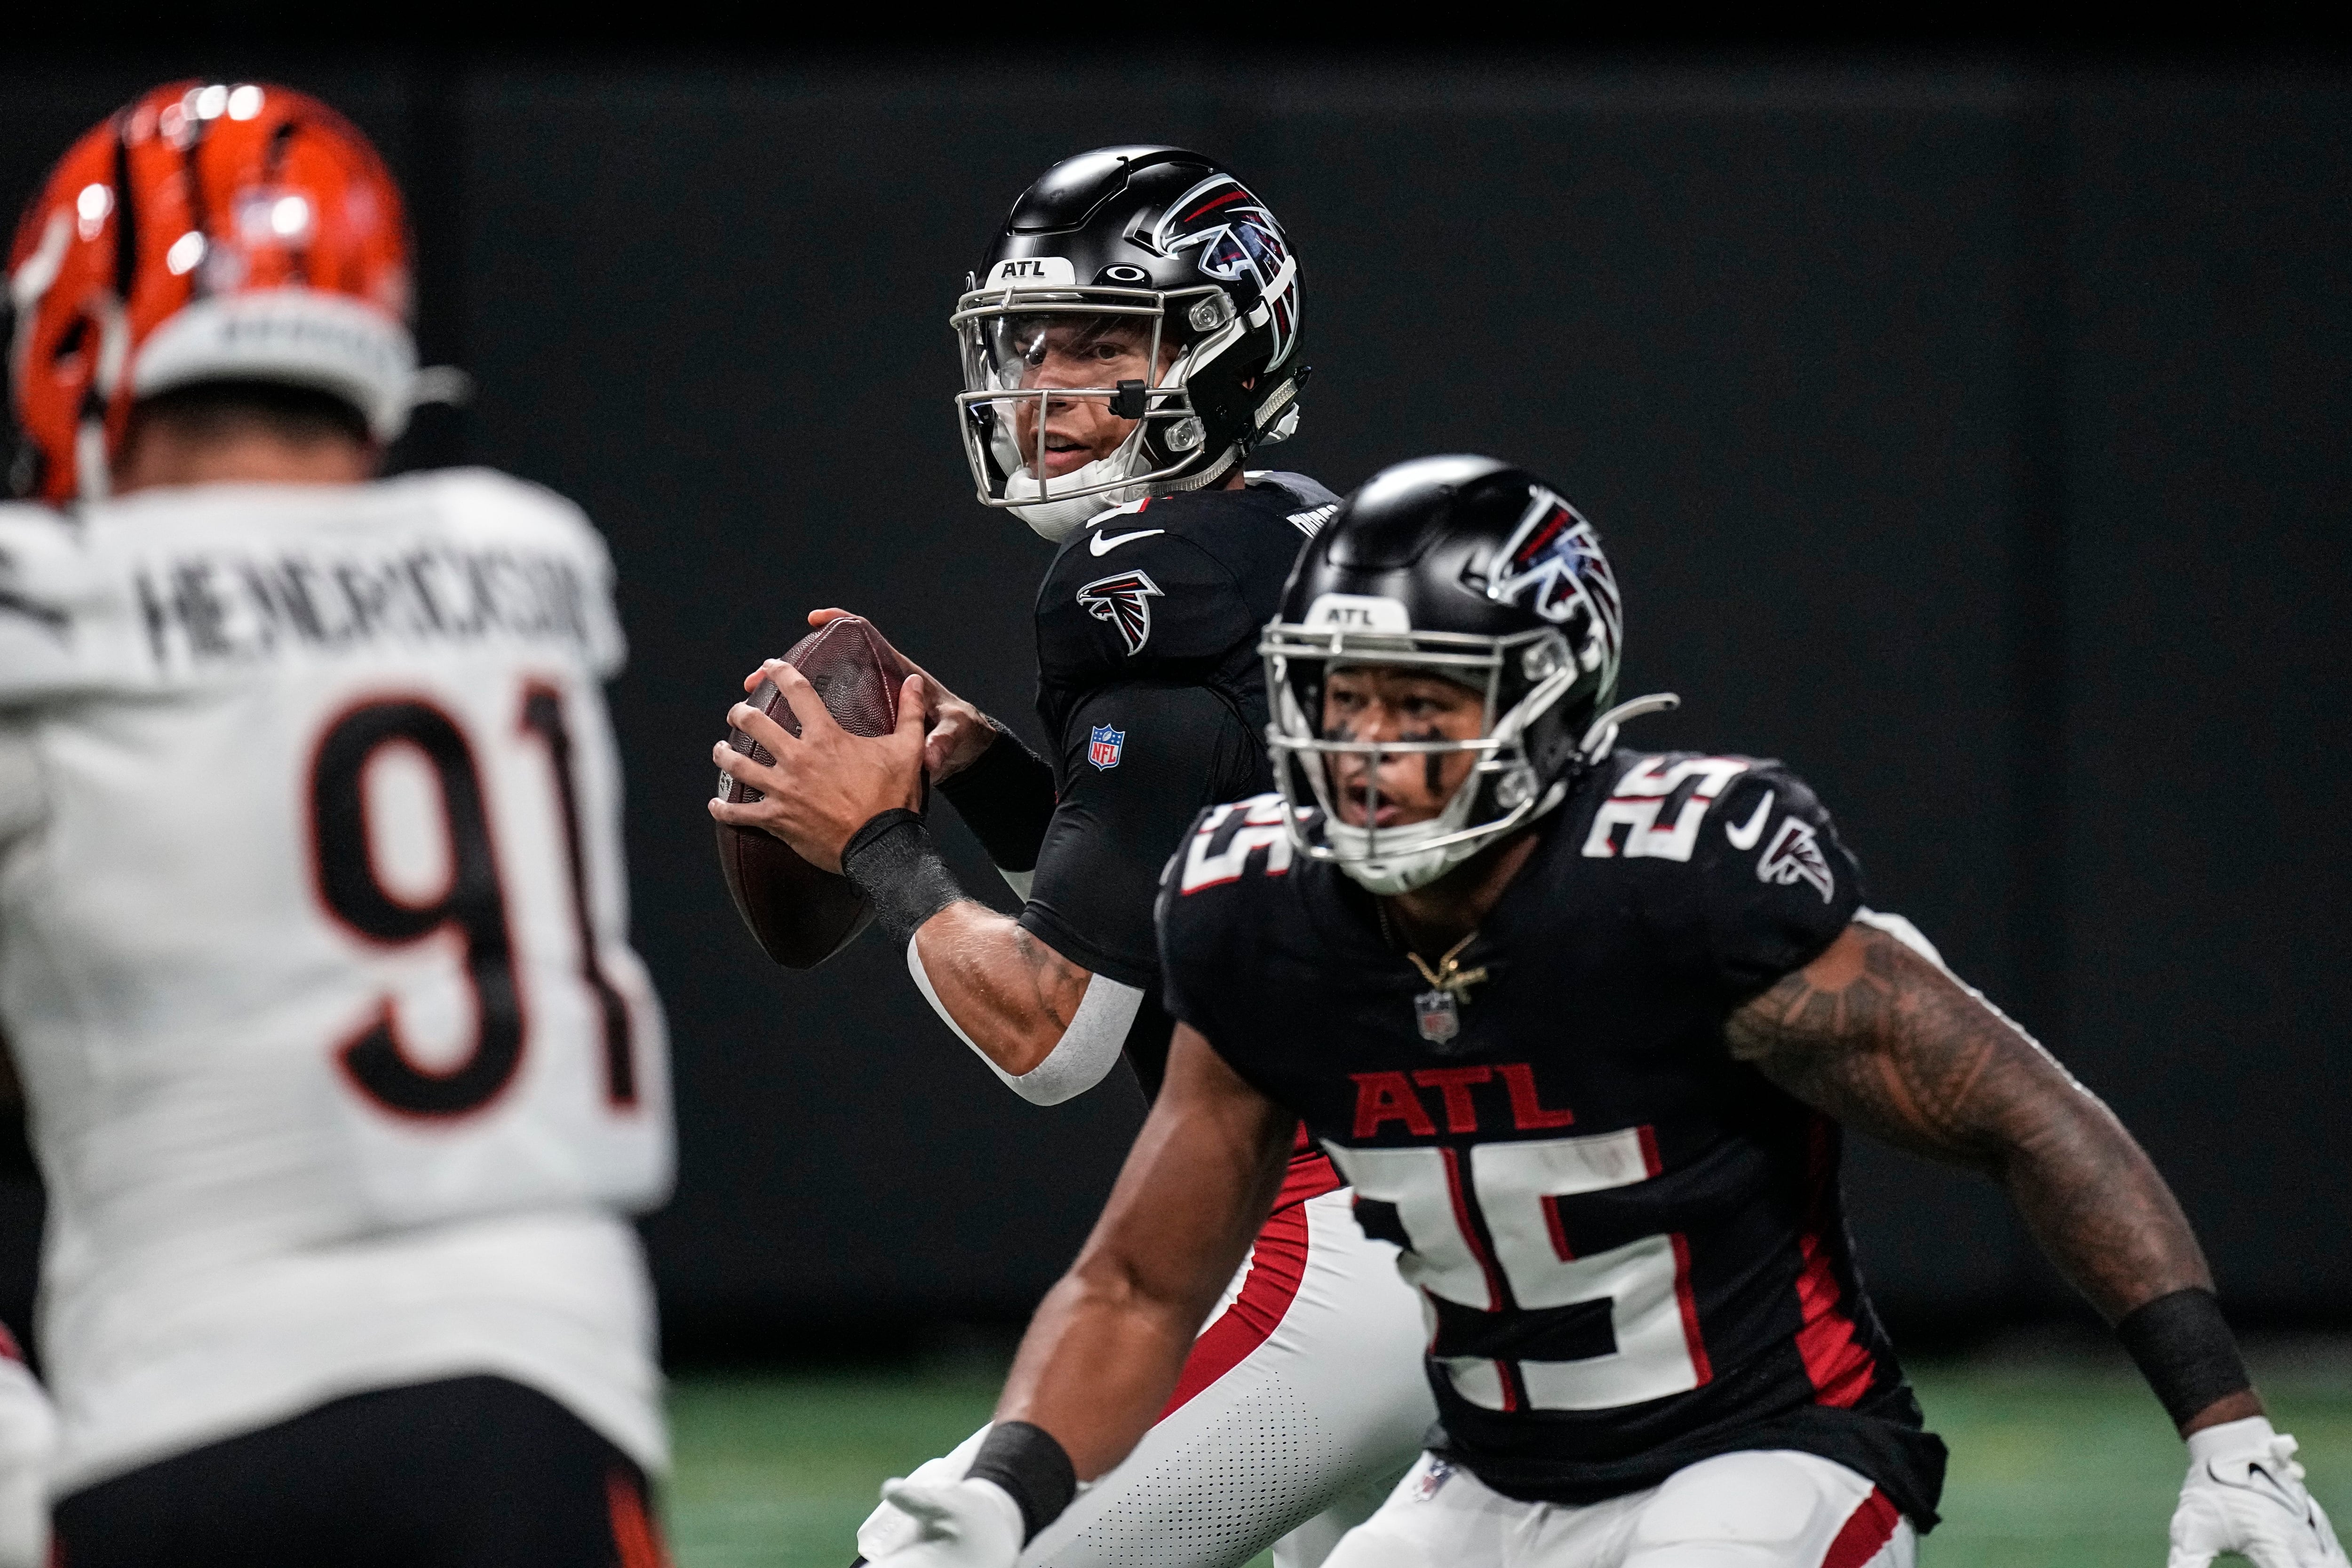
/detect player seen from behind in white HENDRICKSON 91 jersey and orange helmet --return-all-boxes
[0,85,670,1568]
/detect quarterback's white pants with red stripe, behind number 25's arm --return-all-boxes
[858,1187,1437,1568]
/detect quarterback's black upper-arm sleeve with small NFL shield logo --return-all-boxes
[1021,684,1265,990]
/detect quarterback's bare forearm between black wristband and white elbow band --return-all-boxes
[915,903,1094,1077]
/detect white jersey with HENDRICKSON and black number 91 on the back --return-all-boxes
[0,470,670,1493]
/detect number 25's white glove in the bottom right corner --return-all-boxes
[2166,1415,2347,1568]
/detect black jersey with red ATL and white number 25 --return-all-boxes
[1160,752,1943,1528]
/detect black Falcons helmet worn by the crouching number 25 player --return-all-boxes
[1258,456,1675,893]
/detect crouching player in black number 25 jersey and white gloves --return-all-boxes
[856,459,2345,1568]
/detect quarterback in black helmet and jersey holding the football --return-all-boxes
[713,146,1435,1568]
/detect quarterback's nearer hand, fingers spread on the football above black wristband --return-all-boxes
[710,658,922,872]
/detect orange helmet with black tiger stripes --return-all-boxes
[9,82,416,501]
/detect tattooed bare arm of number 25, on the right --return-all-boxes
[1726,924,2263,1432]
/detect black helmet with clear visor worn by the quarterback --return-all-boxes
[950,146,1305,539]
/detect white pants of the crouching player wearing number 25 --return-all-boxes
[1324,1448,1919,1568]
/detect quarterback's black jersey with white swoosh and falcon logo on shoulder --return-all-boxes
[1000,473,1338,1093]
